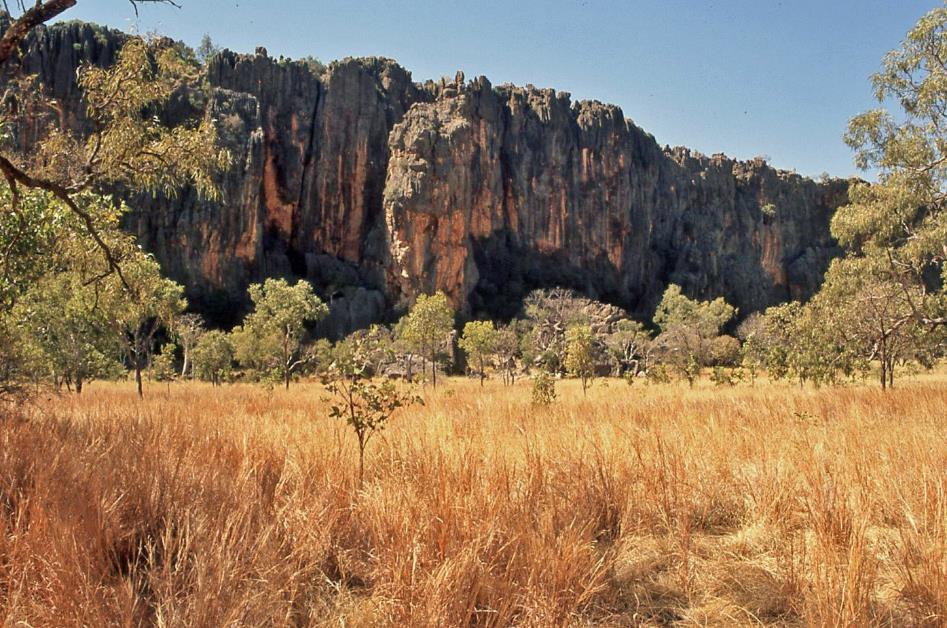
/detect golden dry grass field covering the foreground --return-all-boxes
[0,377,947,626]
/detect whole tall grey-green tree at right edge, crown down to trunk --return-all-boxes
[797,7,947,388]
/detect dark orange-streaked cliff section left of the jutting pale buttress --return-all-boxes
[129,53,426,328]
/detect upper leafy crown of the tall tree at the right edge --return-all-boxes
[832,7,947,326]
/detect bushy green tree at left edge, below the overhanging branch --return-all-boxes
[0,190,191,398]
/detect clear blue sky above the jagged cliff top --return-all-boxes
[63,0,938,176]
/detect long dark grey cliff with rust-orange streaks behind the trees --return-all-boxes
[14,23,847,335]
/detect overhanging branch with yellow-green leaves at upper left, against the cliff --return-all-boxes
[0,30,230,290]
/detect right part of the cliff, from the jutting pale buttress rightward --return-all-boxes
[385,73,847,314]
